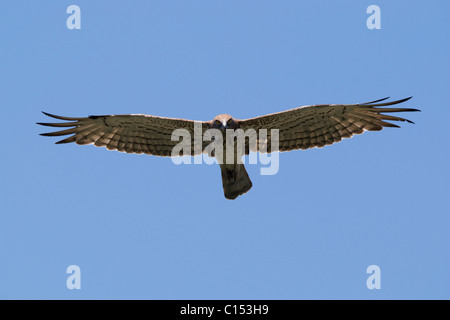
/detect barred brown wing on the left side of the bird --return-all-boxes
[38,112,209,157]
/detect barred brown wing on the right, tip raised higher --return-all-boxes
[238,97,420,153]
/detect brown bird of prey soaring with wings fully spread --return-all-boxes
[37,97,420,200]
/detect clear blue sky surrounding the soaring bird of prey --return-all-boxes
[0,0,450,299]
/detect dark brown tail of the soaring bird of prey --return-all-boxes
[220,164,253,200]
